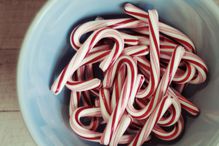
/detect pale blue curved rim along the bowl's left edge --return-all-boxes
[16,0,57,145]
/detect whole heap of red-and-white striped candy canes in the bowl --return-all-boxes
[51,3,208,146]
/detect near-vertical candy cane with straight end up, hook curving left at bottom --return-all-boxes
[136,10,160,98]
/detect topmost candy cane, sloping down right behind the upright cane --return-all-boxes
[124,3,195,52]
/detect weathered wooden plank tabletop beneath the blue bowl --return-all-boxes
[0,0,219,146]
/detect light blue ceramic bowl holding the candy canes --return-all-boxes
[17,0,219,146]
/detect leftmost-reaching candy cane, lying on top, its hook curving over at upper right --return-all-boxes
[51,28,124,94]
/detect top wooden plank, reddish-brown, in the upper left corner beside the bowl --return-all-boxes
[0,0,45,49]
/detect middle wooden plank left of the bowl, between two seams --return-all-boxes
[0,49,19,111]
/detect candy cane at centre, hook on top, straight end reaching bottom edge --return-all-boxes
[101,56,137,145]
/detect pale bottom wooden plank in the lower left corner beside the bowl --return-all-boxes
[0,112,36,146]
